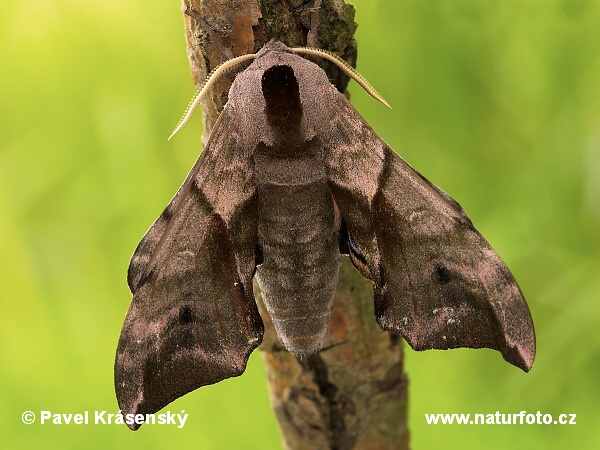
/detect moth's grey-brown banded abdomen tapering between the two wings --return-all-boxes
[256,158,340,355]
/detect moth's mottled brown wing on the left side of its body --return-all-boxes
[115,110,263,429]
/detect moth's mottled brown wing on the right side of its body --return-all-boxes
[325,97,535,371]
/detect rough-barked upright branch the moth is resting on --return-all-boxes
[182,0,409,450]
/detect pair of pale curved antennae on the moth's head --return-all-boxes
[168,41,391,140]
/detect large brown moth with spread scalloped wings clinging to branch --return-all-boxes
[115,41,535,429]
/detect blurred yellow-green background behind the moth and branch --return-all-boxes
[0,0,600,449]
